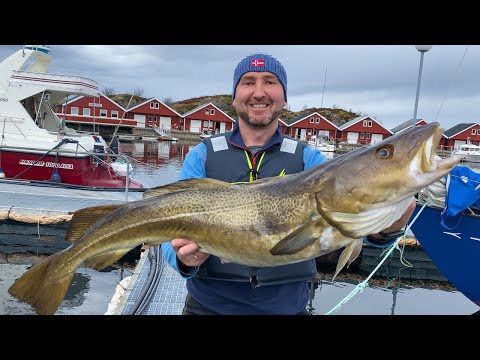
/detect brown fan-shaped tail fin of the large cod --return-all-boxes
[8,254,75,315]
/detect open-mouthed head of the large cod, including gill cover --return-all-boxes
[316,122,460,238]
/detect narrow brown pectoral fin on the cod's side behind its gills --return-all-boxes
[270,220,319,255]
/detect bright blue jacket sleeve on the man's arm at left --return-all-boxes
[162,142,207,279]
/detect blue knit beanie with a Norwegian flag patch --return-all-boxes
[232,53,287,101]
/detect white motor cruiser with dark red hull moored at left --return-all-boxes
[0,45,143,188]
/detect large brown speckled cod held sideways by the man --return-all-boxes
[8,123,460,314]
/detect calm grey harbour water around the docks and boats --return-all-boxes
[0,142,480,315]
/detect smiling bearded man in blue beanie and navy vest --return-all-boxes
[162,53,415,315]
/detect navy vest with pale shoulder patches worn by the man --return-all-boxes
[195,132,316,286]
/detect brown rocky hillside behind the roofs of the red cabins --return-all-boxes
[110,94,360,126]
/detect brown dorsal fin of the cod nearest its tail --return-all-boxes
[65,205,122,243]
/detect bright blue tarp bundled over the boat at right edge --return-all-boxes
[441,166,480,230]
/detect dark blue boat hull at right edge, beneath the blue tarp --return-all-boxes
[411,204,480,305]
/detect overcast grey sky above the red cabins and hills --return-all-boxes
[0,45,480,129]
